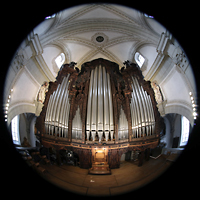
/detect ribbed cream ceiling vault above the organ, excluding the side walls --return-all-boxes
[34,4,165,70]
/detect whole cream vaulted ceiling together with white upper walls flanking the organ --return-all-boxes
[4,4,196,126]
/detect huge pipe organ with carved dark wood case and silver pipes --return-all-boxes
[36,58,164,168]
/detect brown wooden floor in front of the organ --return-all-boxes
[38,155,172,196]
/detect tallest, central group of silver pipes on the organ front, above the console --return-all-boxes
[86,65,114,141]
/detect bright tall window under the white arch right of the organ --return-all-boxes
[180,116,190,146]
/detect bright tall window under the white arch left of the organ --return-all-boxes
[11,115,20,144]
